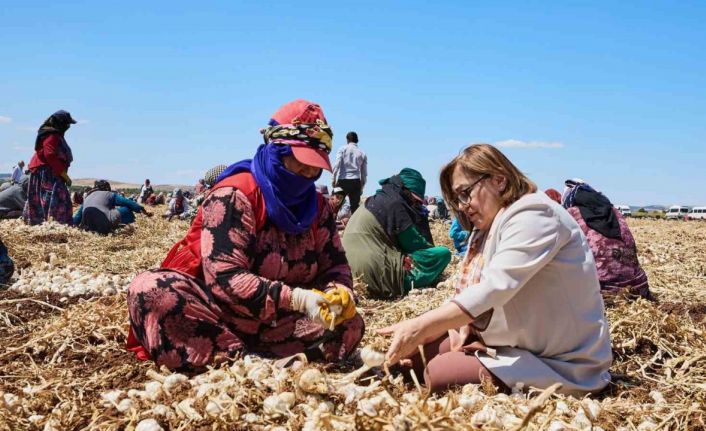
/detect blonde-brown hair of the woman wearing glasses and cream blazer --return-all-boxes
[439,144,537,230]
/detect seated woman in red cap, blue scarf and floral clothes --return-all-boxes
[123,100,364,369]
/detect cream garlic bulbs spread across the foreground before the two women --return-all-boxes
[22,349,661,431]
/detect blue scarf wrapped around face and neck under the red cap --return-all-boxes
[216,144,321,234]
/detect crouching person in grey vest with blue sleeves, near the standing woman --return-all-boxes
[73,180,152,235]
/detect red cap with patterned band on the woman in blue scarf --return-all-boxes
[263,99,333,172]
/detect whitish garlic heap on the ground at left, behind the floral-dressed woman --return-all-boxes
[10,253,132,297]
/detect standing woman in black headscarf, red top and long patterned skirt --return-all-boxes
[22,111,76,225]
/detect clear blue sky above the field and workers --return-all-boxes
[0,1,706,205]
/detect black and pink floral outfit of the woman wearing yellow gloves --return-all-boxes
[128,187,365,369]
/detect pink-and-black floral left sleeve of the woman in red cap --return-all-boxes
[201,187,291,323]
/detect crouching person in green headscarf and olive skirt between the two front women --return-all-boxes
[343,168,451,298]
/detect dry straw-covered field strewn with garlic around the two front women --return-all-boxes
[0,217,706,431]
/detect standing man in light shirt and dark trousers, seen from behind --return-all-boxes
[333,132,368,212]
